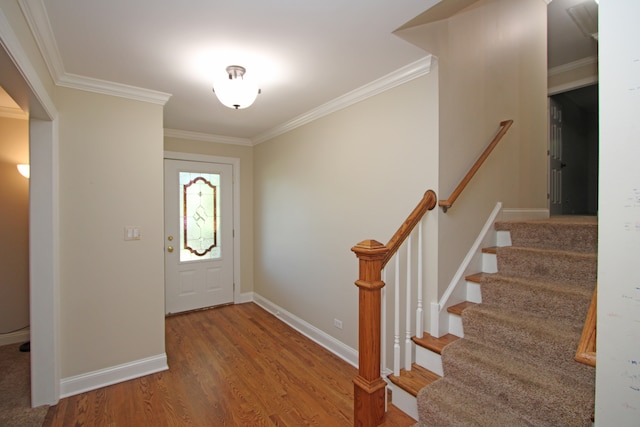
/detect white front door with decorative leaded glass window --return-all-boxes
[164,159,234,314]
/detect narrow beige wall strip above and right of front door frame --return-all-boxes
[164,137,253,293]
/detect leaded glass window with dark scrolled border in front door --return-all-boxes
[180,172,221,262]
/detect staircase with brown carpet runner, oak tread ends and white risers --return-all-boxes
[390,217,597,426]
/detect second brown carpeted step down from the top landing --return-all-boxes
[497,246,597,289]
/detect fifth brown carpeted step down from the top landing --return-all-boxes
[442,339,594,426]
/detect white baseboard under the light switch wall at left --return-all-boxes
[60,353,169,398]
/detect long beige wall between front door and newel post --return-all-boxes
[254,74,438,348]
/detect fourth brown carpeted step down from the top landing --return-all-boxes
[462,304,594,385]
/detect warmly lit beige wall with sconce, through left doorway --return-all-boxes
[0,117,29,334]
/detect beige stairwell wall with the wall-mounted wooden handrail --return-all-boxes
[399,0,547,294]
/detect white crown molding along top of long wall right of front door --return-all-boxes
[252,55,432,145]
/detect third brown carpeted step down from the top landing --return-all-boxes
[480,273,595,323]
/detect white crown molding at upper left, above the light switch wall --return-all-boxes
[19,0,171,105]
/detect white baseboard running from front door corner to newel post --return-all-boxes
[253,292,358,368]
